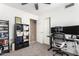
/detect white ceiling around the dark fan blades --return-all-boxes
[5,3,66,15]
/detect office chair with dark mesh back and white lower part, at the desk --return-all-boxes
[52,32,68,56]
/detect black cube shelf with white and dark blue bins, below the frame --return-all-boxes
[14,24,29,50]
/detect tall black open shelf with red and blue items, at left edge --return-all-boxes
[0,20,10,53]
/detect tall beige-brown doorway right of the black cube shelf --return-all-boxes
[30,19,37,43]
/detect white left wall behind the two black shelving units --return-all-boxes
[0,4,38,44]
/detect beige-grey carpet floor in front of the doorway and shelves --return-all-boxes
[2,43,53,56]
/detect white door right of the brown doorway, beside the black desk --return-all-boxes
[43,18,50,44]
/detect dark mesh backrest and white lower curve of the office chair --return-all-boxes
[53,32,66,48]
